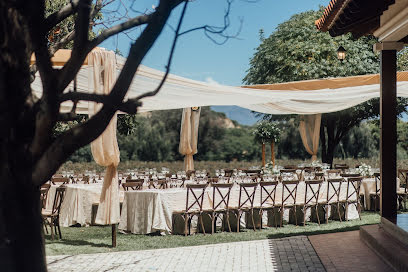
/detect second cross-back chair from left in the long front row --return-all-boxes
[209,183,234,233]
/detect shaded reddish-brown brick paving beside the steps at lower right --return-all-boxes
[309,230,393,272]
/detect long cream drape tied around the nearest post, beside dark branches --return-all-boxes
[88,48,120,225]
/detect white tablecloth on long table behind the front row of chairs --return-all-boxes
[119,182,358,234]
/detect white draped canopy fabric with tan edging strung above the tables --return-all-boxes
[31,52,408,115]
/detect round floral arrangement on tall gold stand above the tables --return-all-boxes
[252,121,281,166]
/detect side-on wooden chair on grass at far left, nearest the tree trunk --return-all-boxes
[41,186,66,240]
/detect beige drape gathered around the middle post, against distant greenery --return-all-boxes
[179,108,201,171]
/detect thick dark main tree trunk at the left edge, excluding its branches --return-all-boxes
[0,4,47,271]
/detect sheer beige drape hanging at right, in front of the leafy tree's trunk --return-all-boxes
[299,114,322,161]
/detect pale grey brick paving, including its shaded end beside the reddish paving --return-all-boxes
[47,236,325,272]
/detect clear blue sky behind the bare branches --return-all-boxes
[102,0,329,86]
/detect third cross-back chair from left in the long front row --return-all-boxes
[235,182,258,232]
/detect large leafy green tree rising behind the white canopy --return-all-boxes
[243,8,406,164]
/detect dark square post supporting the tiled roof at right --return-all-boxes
[380,50,397,223]
